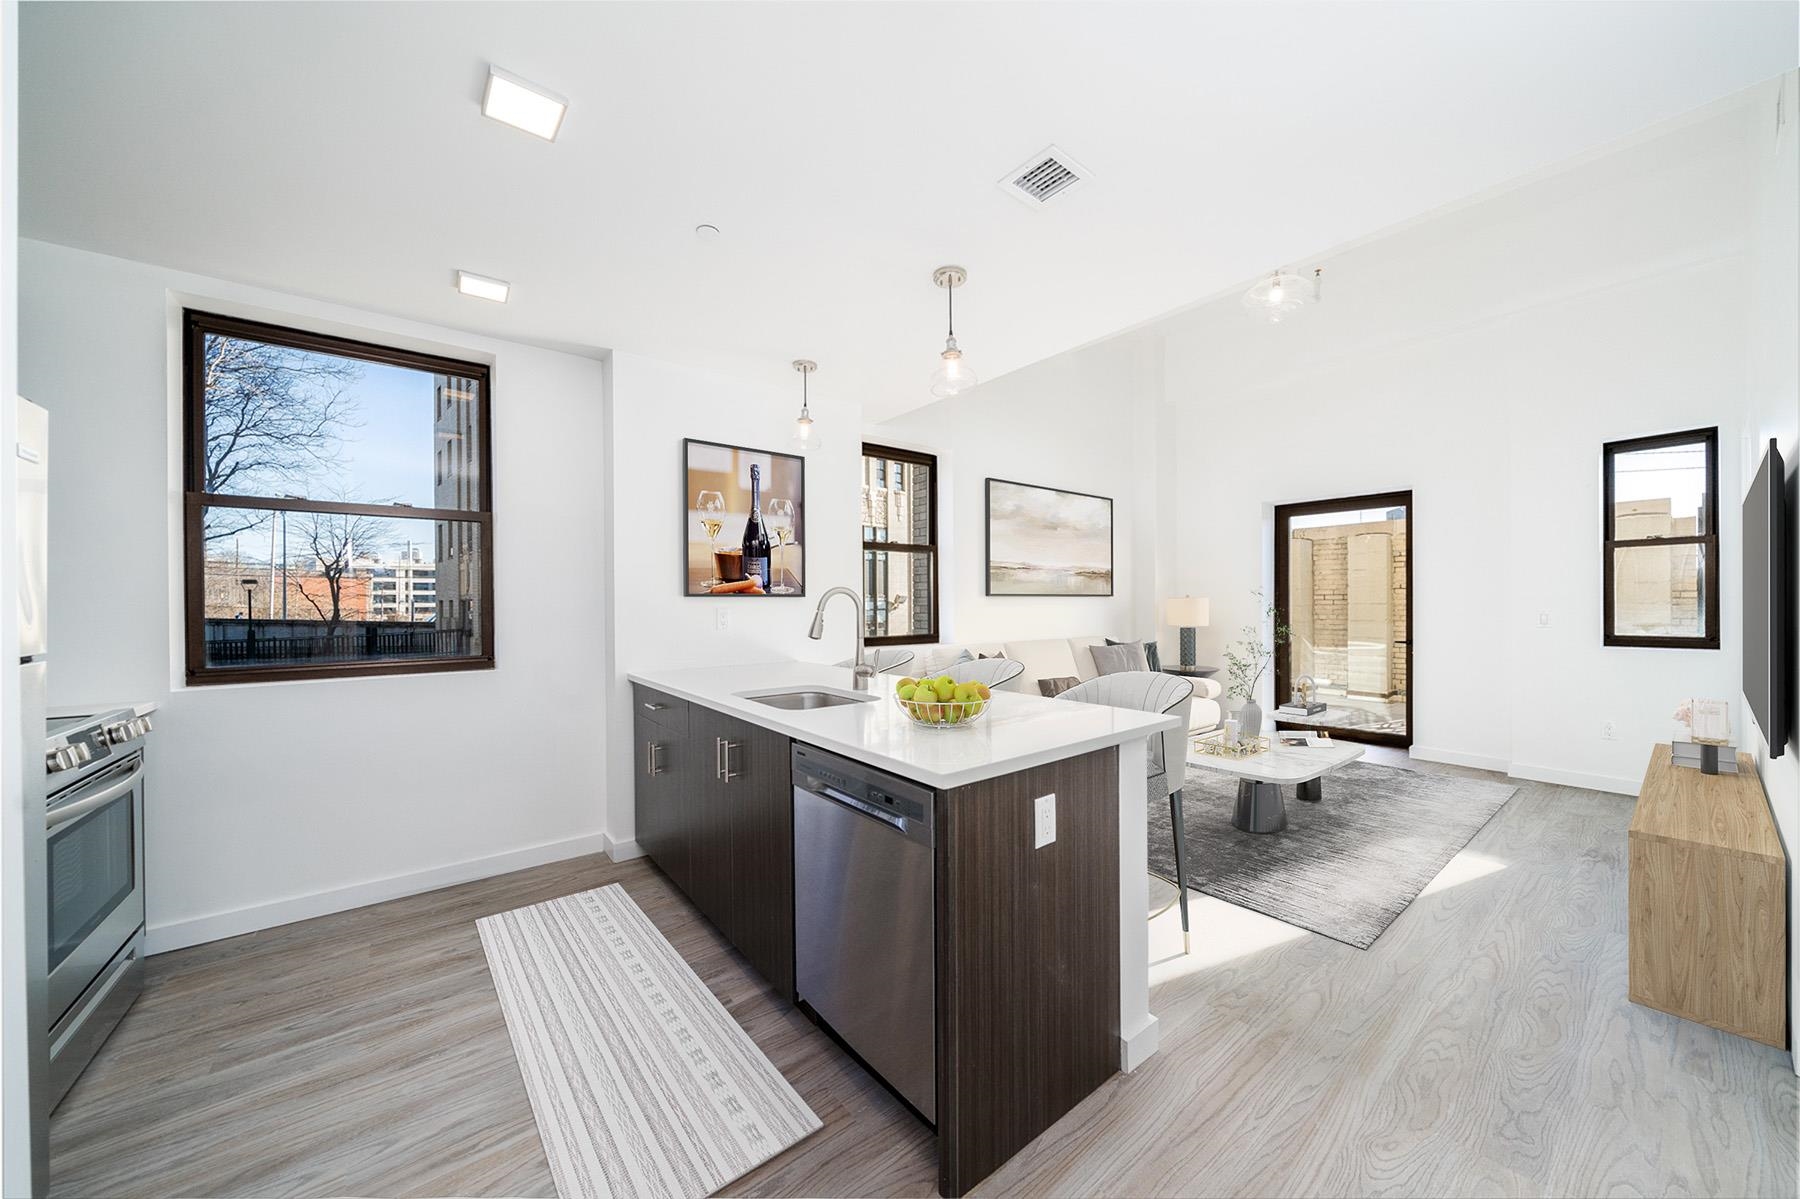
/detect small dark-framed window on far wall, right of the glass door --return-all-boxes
[1600,419,1719,650]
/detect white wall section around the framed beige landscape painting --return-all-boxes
[868,337,1161,655]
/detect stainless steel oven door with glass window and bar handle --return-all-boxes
[43,753,144,1024]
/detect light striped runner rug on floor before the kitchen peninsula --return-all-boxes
[475,884,821,1199]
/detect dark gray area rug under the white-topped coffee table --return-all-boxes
[1148,762,1517,949]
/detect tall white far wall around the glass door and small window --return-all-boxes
[1156,98,1746,794]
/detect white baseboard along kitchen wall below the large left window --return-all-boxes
[144,834,612,954]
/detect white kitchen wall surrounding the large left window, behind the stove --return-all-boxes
[20,241,608,949]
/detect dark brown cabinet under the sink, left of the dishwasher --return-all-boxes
[634,686,794,999]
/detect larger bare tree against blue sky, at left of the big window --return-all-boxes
[203,333,362,542]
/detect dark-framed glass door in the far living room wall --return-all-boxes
[1274,491,1413,749]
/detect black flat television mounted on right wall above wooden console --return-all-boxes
[1744,437,1793,758]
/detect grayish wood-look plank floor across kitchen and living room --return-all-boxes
[50,754,1800,1197]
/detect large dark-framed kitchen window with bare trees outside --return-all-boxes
[182,310,493,684]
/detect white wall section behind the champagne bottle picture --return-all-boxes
[601,351,862,857]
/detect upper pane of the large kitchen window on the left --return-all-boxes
[202,333,484,509]
